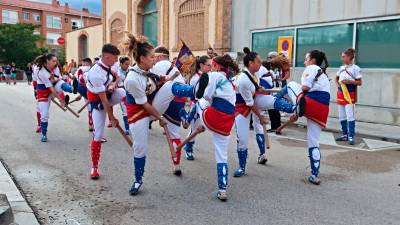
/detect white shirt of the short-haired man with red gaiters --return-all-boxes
[86,60,113,94]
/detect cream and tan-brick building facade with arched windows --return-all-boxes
[66,0,232,59]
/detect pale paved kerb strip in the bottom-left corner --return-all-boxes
[0,162,39,225]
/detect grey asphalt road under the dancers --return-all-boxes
[0,83,400,225]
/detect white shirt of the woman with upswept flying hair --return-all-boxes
[124,65,148,105]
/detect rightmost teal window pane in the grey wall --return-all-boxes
[356,20,400,68]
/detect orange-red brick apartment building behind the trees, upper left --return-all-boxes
[0,0,101,49]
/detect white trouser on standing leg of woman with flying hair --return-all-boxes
[129,117,150,158]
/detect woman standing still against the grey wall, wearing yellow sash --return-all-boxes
[336,48,362,145]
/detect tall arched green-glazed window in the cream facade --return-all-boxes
[142,0,158,46]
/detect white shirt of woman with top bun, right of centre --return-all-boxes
[236,68,257,107]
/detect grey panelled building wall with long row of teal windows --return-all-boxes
[232,0,400,125]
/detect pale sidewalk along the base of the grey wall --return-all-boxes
[296,117,400,143]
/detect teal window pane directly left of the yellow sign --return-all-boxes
[252,29,294,59]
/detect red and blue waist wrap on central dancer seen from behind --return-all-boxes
[203,98,235,136]
